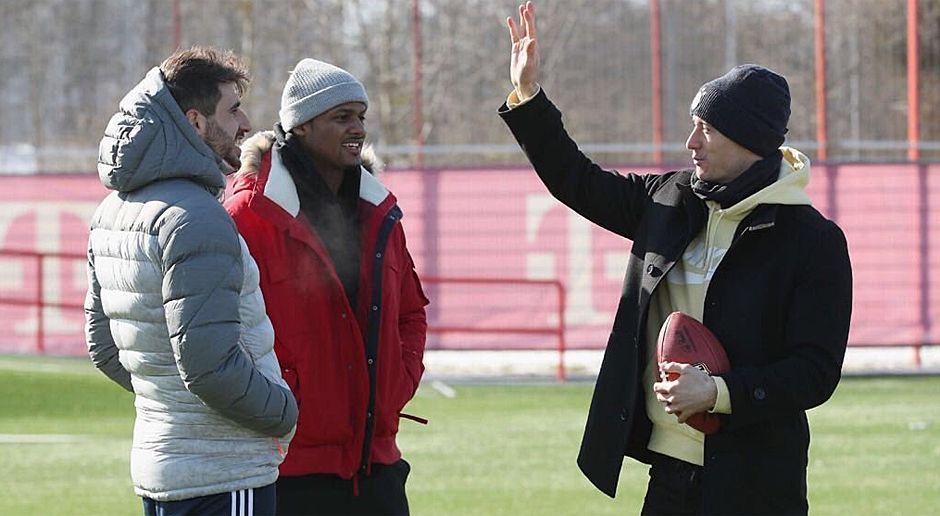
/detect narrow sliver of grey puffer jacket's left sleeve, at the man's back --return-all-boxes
[85,245,134,392]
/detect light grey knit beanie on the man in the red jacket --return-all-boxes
[278,58,369,131]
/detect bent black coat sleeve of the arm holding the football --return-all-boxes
[721,223,852,429]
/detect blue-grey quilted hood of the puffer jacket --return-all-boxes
[98,67,229,194]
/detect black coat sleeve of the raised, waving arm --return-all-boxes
[499,89,658,239]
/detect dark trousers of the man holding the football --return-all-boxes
[640,453,703,515]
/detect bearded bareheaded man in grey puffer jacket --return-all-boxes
[85,47,297,515]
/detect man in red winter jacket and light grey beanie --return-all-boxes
[225,59,428,514]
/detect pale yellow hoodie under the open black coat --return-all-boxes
[643,147,812,466]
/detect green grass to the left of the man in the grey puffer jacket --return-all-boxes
[0,358,142,515]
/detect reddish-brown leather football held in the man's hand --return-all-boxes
[656,312,731,434]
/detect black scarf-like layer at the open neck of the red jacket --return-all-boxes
[274,124,360,310]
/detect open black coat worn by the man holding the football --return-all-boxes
[500,92,852,514]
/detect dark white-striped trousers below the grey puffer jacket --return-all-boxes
[143,484,277,516]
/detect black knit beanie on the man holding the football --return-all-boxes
[689,64,790,157]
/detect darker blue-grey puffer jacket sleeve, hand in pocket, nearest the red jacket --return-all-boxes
[160,205,297,437]
